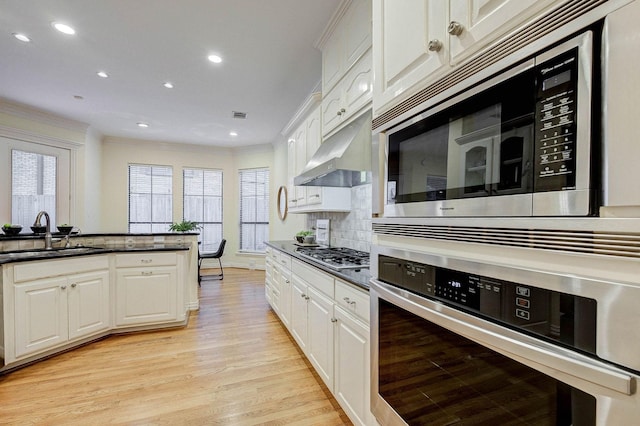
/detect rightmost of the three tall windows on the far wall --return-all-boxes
[240,169,269,252]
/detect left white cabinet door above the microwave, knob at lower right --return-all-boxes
[373,0,449,116]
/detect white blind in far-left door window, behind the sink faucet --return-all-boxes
[11,149,58,233]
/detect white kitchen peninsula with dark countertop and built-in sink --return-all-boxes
[0,234,199,372]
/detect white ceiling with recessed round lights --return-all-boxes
[0,0,341,147]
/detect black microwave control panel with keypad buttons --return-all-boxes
[534,48,578,192]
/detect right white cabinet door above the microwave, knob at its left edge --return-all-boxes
[449,0,559,65]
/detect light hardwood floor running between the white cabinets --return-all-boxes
[0,268,351,426]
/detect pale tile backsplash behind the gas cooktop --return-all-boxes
[307,184,372,252]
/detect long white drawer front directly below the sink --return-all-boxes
[13,255,109,283]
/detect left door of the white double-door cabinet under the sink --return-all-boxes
[14,277,69,358]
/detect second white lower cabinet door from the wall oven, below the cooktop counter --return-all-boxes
[307,287,335,391]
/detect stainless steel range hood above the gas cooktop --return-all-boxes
[293,111,372,187]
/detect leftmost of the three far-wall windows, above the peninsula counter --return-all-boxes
[129,164,173,233]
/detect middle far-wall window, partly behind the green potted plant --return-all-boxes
[182,169,222,252]
